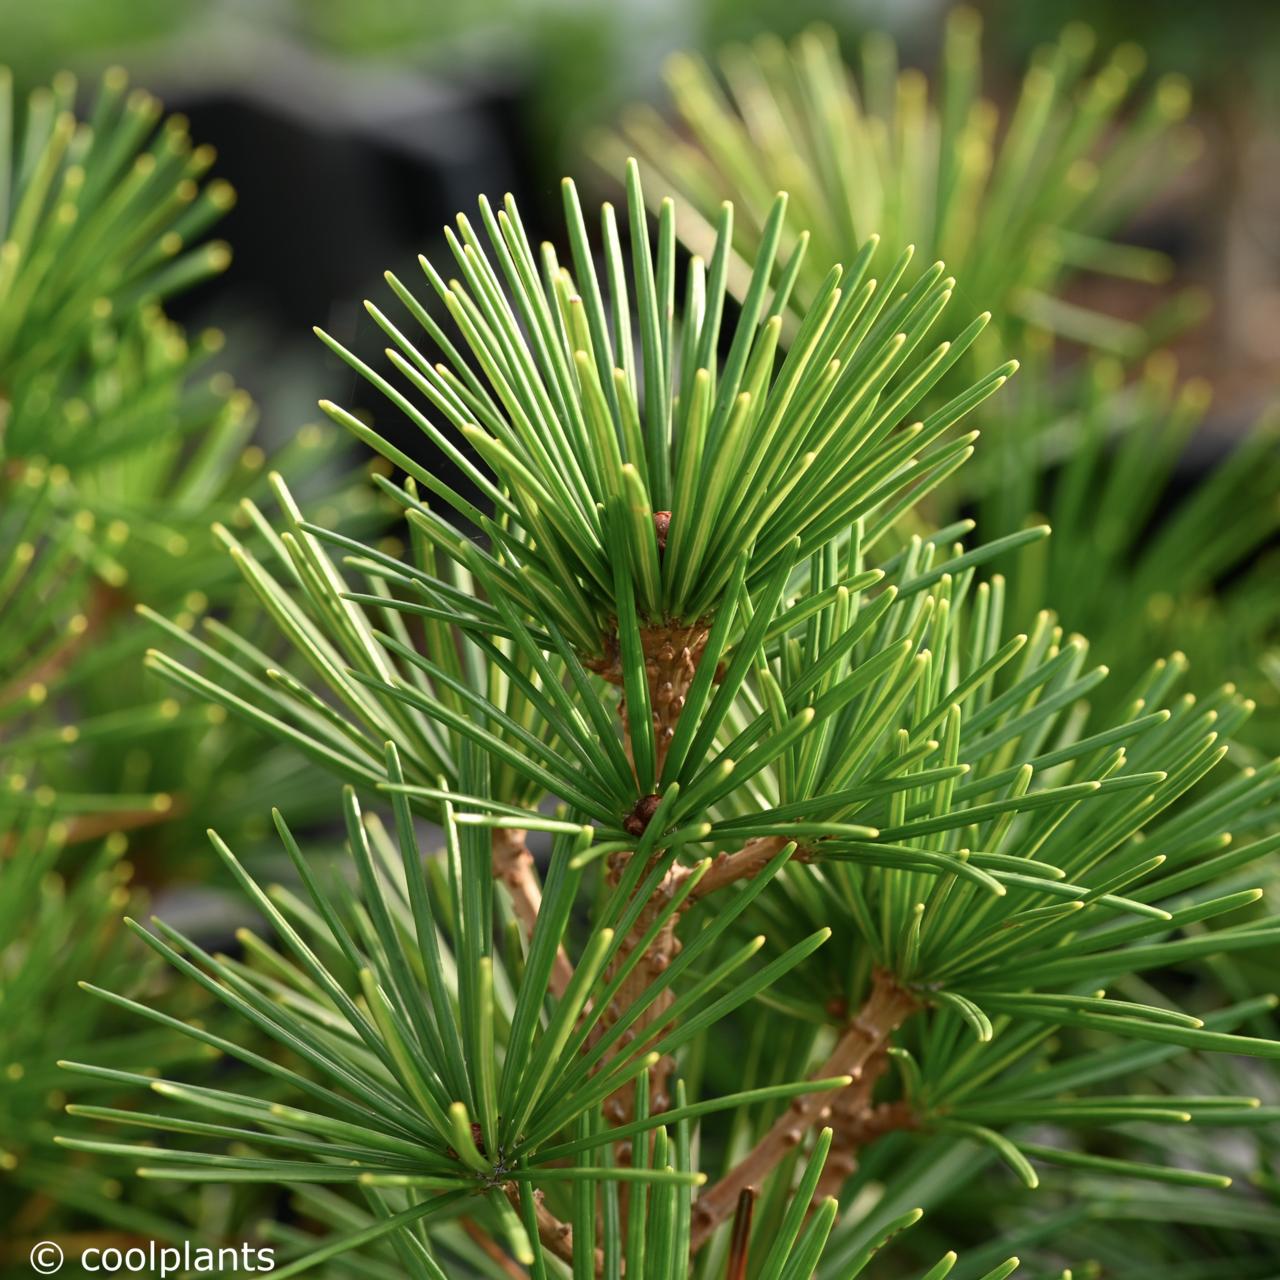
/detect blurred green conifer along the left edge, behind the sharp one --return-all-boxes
[0,68,366,1249]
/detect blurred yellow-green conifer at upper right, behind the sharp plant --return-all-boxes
[596,15,1280,754]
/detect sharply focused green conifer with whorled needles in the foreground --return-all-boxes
[61,165,1280,1280]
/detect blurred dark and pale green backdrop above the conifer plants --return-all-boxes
[0,0,1280,434]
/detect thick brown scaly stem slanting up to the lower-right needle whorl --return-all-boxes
[691,969,916,1252]
